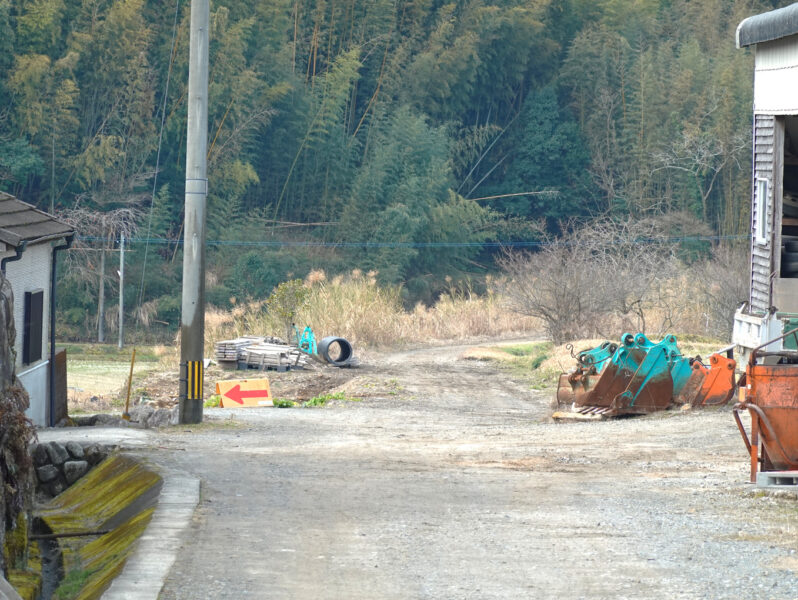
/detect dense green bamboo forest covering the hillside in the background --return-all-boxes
[0,0,790,338]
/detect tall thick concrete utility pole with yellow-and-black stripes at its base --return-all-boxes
[179,0,210,423]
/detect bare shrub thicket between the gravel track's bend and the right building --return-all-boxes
[496,215,748,343]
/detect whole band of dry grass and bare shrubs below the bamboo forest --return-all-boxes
[200,227,747,355]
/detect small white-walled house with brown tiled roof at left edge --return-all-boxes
[0,192,74,426]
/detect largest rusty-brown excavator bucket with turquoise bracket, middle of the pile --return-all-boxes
[574,333,680,417]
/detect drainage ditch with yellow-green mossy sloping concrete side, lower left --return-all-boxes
[12,442,164,600]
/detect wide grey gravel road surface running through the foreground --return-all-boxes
[149,347,798,600]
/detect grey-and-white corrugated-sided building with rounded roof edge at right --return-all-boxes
[735,3,798,348]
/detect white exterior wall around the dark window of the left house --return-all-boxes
[0,242,53,426]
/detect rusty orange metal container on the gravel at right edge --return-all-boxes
[734,332,798,482]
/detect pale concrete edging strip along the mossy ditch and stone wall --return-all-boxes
[38,427,200,600]
